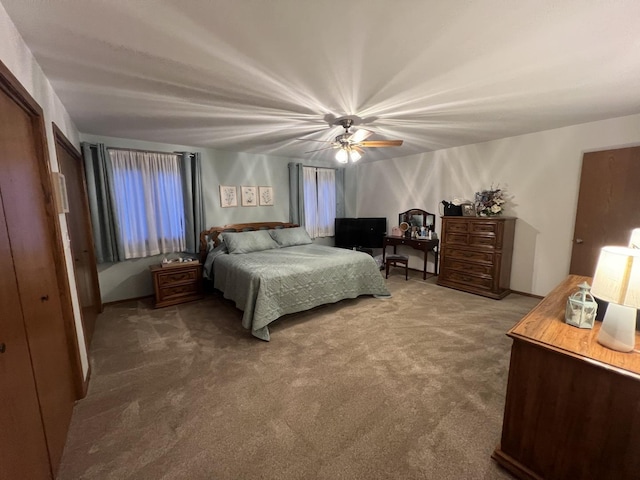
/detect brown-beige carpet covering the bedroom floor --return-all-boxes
[58,270,539,480]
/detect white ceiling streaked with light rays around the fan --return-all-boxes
[0,0,640,160]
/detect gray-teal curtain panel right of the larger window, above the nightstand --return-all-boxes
[178,152,205,254]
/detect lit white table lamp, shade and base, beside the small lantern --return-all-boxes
[591,247,640,352]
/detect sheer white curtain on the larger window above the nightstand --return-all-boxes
[109,150,186,258]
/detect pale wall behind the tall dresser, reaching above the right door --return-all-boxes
[356,115,640,296]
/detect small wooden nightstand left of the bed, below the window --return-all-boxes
[149,262,203,308]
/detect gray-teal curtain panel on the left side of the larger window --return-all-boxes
[81,142,125,263]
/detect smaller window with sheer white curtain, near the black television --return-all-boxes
[302,167,336,238]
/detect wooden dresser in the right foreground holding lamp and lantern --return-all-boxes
[492,275,640,480]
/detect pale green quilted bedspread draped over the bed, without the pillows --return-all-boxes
[208,244,390,341]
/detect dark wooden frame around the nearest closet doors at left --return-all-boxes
[0,61,89,399]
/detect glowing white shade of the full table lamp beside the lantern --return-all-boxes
[591,247,640,308]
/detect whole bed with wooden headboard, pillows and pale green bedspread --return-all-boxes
[200,222,390,341]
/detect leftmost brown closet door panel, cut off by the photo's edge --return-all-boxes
[0,195,50,480]
